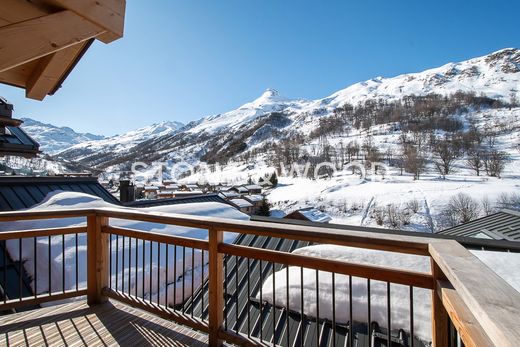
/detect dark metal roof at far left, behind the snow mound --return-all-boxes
[0,176,120,211]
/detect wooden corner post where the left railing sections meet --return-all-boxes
[87,215,110,305]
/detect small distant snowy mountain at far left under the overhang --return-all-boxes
[22,118,104,154]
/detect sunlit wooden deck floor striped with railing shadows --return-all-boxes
[0,301,208,347]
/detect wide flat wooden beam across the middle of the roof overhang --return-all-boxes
[0,11,105,72]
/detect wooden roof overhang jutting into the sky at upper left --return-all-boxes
[0,0,126,100]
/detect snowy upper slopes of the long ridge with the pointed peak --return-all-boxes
[54,48,520,168]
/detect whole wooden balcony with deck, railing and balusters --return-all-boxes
[0,207,520,346]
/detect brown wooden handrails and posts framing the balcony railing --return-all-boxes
[0,208,520,346]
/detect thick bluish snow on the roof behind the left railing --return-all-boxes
[0,191,249,303]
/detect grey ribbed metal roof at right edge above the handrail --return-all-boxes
[439,210,520,241]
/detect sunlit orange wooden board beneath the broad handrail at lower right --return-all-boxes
[435,281,494,347]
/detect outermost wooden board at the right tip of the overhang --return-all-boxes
[49,0,126,43]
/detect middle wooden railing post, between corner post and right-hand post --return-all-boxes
[208,228,224,346]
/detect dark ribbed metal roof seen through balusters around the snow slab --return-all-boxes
[184,234,425,347]
